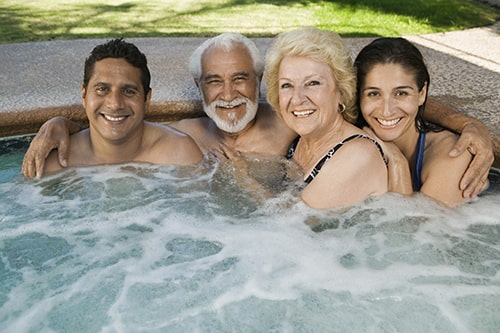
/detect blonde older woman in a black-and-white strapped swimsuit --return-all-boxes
[265,28,387,209]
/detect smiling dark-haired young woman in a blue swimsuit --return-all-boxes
[354,38,472,207]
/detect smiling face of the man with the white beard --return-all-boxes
[198,45,259,133]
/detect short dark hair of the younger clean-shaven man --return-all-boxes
[83,38,151,99]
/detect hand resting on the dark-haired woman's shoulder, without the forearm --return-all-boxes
[449,121,495,198]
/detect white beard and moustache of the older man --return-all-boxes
[203,98,259,133]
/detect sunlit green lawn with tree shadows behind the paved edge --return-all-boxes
[0,0,500,43]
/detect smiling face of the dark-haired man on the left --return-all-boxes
[82,58,151,142]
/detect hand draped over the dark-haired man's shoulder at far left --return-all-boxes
[21,117,83,178]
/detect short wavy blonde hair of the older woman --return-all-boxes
[265,27,358,123]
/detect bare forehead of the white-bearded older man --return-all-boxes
[201,44,255,76]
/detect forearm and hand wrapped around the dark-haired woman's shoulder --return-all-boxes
[425,99,494,198]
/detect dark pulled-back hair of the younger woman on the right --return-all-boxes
[354,37,440,132]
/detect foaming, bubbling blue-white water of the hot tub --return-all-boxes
[0,136,500,332]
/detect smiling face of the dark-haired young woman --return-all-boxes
[360,64,426,143]
